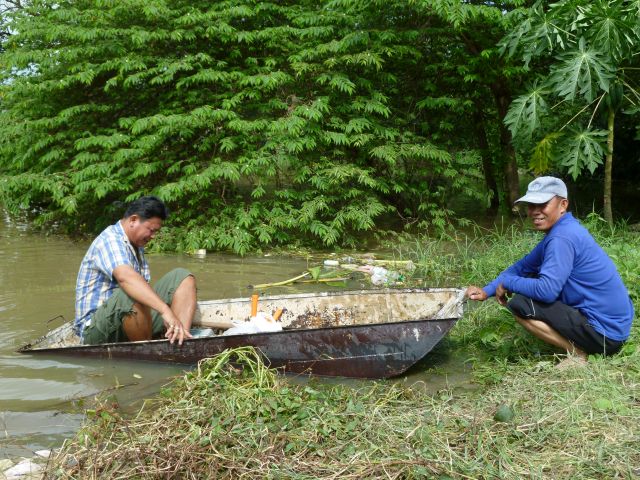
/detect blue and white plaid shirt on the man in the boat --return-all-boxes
[74,221,151,338]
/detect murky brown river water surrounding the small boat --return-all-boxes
[0,213,468,458]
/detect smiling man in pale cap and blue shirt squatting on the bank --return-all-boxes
[466,177,634,360]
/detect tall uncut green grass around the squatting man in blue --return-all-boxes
[395,214,640,361]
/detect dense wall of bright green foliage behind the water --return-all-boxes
[0,0,633,253]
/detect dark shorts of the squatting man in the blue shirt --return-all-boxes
[507,293,624,355]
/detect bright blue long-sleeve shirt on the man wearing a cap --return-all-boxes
[483,213,634,341]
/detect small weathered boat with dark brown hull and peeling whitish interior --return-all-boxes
[19,288,464,378]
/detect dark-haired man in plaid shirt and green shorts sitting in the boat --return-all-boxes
[74,196,196,345]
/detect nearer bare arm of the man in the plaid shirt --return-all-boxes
[113,265,185,344]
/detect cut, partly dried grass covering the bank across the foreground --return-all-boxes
[47,348,640,479]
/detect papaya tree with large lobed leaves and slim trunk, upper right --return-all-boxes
[502,0,640,223]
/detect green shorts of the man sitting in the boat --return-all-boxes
[83,268,191,345]
